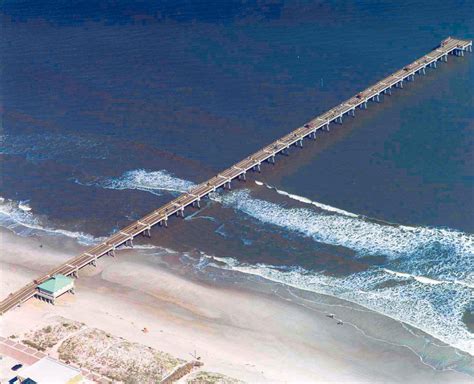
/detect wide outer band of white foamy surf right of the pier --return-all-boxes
[219,190,474,281]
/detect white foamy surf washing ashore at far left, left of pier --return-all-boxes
[0,197,100,245]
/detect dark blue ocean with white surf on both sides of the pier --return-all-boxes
[0,1,474,360]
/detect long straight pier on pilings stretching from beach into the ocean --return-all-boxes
[0,37,472,315]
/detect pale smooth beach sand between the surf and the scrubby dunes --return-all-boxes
[0,230,472,383]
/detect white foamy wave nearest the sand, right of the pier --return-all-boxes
[206,256,474,355]
